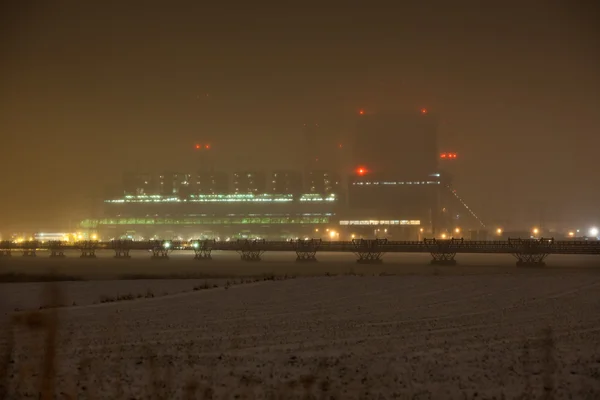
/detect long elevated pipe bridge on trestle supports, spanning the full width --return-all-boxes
[0,238,600,266]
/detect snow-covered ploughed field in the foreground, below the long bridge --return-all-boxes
[0,267,600,399]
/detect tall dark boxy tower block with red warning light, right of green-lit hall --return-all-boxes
[348,110,444,239]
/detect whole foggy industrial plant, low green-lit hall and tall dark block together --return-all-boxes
[81,110,481,240]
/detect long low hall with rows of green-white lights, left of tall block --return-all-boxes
[81,170,340,238]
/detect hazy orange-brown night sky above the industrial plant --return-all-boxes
[0,0,600,231]
